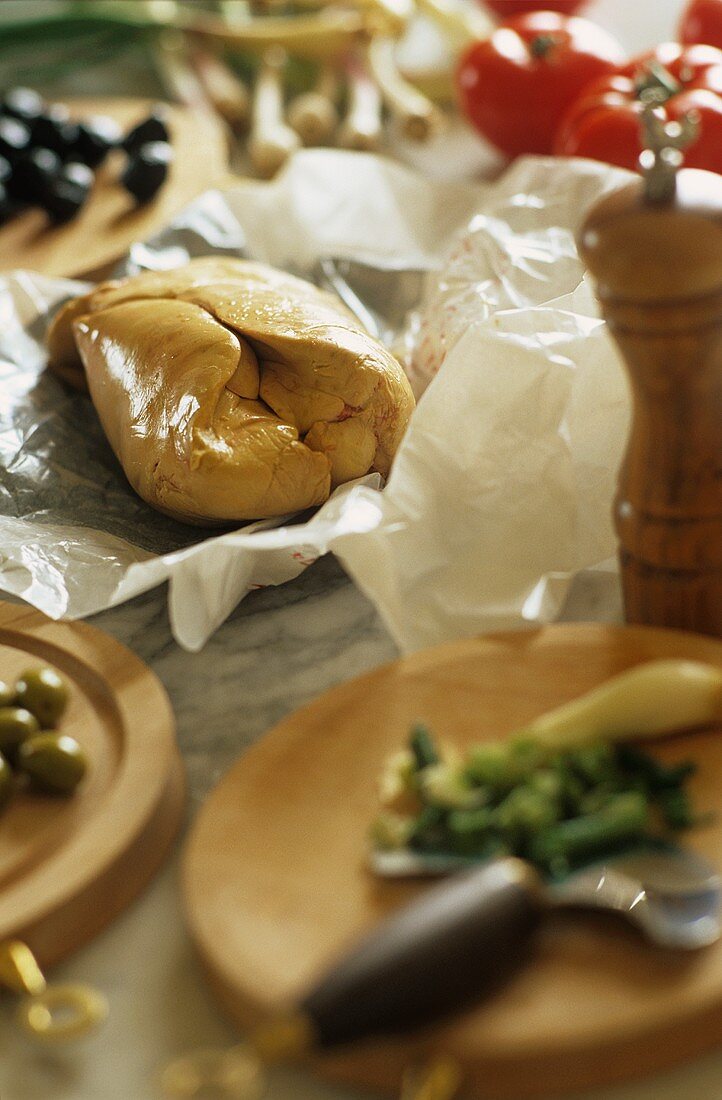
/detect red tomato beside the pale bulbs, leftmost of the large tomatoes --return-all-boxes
[457,11,624,156]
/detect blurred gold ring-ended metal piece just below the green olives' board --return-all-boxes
[0,939,108,1043]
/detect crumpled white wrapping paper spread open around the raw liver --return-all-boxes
[0,143,628,650]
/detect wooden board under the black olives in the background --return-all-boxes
[0,99,229,277]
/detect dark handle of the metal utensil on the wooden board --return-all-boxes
[300,859,542,1047]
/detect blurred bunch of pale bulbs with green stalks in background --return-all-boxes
[0,0,479,176]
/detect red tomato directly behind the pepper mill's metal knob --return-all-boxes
[554,42,722,173]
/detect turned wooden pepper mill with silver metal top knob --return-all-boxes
[579,103,722,636]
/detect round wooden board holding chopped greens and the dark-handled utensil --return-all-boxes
[184,624,722,1098]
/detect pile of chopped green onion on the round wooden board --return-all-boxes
[371,723,703,877]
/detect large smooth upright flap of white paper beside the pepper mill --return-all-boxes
[333,279,628,650]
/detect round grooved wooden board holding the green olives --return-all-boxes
[0,604,183,965]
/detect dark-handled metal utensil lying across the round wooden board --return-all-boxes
[246,844,722,1060]
